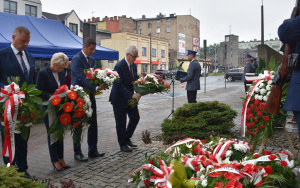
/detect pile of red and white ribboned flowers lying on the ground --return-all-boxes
[129,138,299,188]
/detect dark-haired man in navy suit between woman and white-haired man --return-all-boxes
[71,38,105,162]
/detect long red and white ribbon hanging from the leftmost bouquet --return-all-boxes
[0,83,25,163]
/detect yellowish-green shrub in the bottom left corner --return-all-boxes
[0,165,47,188]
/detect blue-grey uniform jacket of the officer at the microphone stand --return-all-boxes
[180,59,201,91]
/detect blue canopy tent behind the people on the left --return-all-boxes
[0,12,119,60]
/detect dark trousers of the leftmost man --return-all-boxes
[0,123,30,172]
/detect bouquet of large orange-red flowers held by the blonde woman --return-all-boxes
[47,85,93,145]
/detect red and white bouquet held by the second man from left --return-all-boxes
[84,68,119,95]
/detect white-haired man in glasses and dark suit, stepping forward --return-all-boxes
[109,46,141,152]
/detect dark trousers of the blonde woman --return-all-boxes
[44,116,64,163]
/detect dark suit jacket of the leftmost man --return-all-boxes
[0,46,35,88]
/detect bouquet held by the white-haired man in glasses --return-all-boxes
[128,74,170,108]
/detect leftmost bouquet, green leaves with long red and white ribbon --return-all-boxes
[0,77,42,163]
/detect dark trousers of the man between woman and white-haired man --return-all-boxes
[73,94,98,155]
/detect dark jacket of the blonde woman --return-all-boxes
[36,66,65,101]
